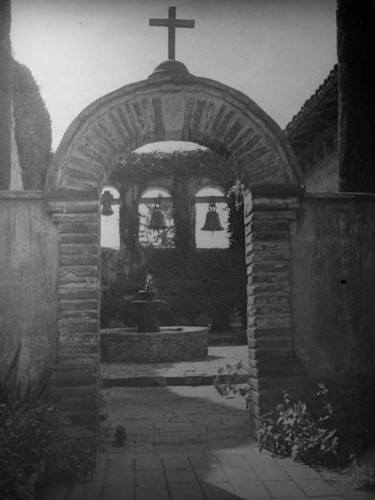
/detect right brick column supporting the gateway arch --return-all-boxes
[244,191,298,429]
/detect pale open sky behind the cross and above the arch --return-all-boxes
[11,0,337,150]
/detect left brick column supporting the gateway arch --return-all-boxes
[49,197,100,440]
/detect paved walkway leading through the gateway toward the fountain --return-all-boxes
[39,347,375,500]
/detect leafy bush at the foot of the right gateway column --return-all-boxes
[258,384,338,466]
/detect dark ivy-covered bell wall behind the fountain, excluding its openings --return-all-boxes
[101,150,247,331]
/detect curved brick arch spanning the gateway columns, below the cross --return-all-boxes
[46,75,301,193]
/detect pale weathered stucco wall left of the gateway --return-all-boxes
[0,191,58,389]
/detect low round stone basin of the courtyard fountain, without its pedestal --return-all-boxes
[100,326,208,363]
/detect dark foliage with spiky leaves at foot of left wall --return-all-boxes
[0,349,95,500]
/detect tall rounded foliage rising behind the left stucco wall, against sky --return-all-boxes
[12,60,52,189]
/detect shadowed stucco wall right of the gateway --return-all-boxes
[292,194,375,375]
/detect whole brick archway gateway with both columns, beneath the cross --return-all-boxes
[46,60,302,435]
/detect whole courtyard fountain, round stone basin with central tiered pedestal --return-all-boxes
[100,275,208,363]
